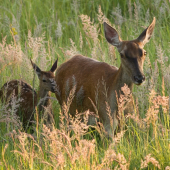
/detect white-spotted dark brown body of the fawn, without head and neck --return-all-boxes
[0,80,37,126]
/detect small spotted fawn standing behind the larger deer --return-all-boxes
[0,59,58,129]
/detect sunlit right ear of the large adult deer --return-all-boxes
[137,17,156,47]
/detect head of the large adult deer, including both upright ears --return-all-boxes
[104,18,156,85]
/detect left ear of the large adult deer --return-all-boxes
[104,22,122,48]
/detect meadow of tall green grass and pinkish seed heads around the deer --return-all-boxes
[0,0,170,170]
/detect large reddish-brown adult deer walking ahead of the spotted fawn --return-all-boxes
[55,18,155,136]
